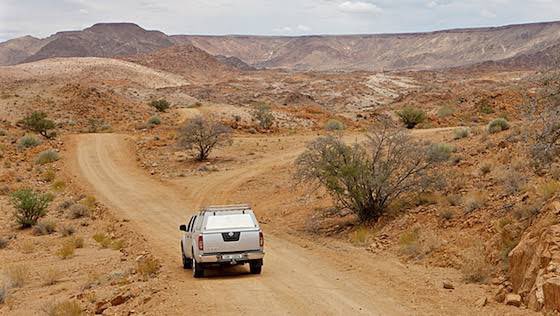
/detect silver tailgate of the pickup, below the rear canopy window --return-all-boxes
[203,229,260,253]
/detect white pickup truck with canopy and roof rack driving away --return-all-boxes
[179,205,264,278]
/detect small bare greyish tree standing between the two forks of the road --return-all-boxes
[179,116,231,161]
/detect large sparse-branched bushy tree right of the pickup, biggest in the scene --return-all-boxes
[296,127,442,221]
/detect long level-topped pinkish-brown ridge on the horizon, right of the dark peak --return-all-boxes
[173,22,560,71]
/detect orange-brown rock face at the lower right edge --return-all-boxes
[509,202,560,311]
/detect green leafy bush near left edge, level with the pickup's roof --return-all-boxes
[12,189,52,228]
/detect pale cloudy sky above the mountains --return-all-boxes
[0,0,560,41]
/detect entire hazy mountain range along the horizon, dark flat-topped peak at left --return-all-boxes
[0,22,560,71]
